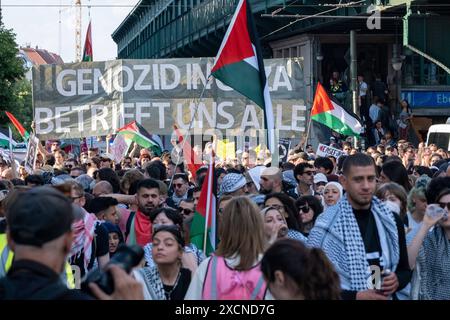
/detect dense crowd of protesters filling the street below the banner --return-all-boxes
[0,127,450,300]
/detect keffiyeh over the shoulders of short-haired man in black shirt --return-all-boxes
[308,196,400,291]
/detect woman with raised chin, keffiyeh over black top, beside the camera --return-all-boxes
[133,225,191,300]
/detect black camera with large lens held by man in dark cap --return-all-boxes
[81,244,144,294]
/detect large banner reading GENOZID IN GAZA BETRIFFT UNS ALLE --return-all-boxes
[33,58,306,140]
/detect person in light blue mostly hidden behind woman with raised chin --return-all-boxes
[144,208,205,272]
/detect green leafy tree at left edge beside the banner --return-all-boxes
[0,25,29,138]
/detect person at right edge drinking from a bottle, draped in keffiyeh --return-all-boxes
[408,189,450,300]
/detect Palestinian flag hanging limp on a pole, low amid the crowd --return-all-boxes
[190,156,217,256]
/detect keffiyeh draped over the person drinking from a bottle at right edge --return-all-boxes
[411,226,450,300]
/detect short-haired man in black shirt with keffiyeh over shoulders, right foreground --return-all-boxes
[308,153,411,300]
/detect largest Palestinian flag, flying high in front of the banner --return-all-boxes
[211,0,277,153]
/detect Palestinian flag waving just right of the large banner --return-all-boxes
[311,83,362,136]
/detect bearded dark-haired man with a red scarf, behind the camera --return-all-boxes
[125,179,161,247]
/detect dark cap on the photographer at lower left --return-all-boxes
[6,186,74,247]
